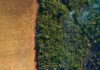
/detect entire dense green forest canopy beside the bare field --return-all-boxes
[36,0,100,70]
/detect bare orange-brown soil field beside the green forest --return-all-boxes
[0,0,38,70]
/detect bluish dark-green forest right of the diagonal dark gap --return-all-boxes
[61,0,100,70]
